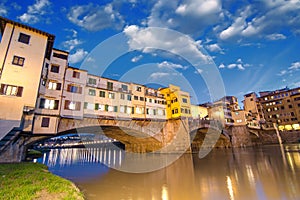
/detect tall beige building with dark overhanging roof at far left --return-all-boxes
[0,17,55,139]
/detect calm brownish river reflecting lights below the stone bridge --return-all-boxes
[37,144,300,200]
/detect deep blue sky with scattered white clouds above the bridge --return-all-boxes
[0,0,300,107]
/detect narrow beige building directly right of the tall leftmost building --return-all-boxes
[33,49,68,134]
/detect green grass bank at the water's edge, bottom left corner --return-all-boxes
[0,163,84,200]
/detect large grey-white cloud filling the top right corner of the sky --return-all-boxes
[218,0,300,40]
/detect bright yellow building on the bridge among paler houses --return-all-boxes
[159,84,192,119]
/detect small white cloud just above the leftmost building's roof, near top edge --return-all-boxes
[18,0,51,24]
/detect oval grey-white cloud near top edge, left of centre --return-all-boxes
[68,3,124,31]
